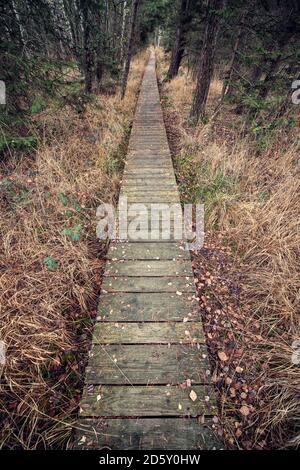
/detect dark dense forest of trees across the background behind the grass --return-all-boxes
[1,0,299,140]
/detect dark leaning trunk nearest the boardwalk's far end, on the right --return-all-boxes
[167,0,190,80]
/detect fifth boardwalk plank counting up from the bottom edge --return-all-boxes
[97,293,201,322]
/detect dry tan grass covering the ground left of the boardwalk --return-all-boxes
[0,50,146,449]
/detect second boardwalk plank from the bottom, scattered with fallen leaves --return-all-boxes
[80,385,217,417]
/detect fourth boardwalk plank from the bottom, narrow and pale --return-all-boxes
[93,322,204,344]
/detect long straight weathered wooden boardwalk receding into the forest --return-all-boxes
[76,53,220,450]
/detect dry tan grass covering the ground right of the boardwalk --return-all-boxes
[160,47,300,448]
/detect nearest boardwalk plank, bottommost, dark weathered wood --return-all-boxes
[75,418,223,450]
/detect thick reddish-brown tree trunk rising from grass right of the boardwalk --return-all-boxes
[190,0,224,124]
